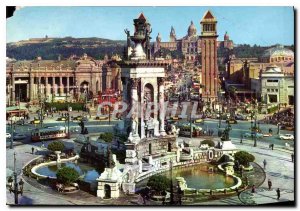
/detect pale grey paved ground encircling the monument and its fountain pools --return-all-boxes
[6,123,294,205]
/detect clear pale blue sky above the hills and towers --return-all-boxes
[6,6,294,46]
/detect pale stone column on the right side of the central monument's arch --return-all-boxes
[158,78,166,136]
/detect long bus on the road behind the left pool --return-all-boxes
[31,126,68,141]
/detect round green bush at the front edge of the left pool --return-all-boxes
[56,167,80,185]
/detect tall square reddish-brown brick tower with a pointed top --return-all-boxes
[200,10,218,102]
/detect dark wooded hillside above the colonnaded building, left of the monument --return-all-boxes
[6,37,126,60]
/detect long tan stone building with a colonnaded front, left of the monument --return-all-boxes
[6,54,122,102]
